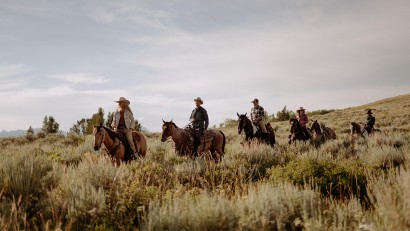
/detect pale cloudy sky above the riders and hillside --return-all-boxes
[0,0,410,131]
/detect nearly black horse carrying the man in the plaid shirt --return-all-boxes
[236,113,276,147]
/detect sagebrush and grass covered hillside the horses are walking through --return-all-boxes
[0,94,410,230]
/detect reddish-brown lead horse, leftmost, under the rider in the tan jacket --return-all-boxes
[93,124,147,165]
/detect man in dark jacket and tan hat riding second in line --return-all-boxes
[189,97,209,155]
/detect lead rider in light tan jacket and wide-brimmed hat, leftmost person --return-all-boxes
[111,97,137,156]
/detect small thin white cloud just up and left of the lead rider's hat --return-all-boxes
[49,73,110,84]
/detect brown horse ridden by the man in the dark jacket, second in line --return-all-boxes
[161,120,226,162]
